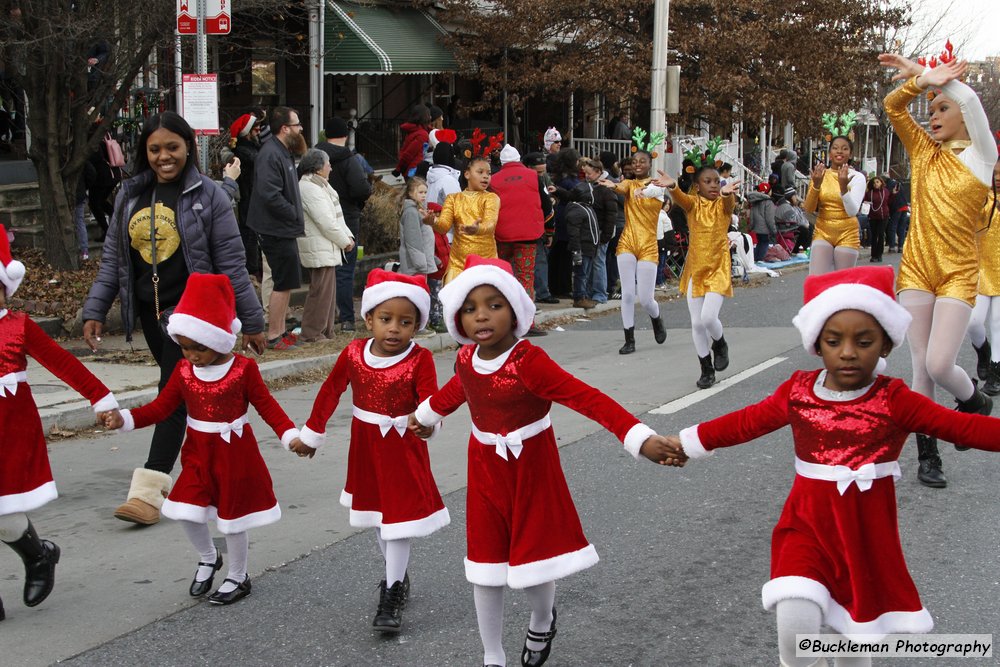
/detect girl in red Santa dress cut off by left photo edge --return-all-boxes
[0,234,118,621]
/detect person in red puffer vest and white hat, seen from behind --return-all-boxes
[490,144,552,336]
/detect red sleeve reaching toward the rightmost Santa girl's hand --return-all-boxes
[521,347,639,442]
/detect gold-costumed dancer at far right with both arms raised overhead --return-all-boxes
[879,50,997,488]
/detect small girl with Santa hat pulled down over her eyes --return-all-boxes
[105,273,298,605]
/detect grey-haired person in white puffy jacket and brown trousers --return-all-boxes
[297,148,354,343]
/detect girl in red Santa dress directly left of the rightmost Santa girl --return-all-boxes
[410,255,673,667]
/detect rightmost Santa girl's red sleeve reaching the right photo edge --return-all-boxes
[889,380,1000,452]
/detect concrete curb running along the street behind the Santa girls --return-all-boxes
[38,264,809,433]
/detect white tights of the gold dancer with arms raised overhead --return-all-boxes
[899,289,975,401]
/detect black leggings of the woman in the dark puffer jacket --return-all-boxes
[136,302,187,475]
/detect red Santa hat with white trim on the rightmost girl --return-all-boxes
[792,266,912,354]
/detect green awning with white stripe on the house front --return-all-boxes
[323,0,458,74]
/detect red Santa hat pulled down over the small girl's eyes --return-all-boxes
[167,273,242,354]
